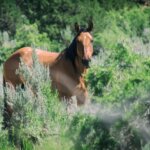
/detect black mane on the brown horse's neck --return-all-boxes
[65,28,87,65]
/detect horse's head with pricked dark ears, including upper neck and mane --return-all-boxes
[65,21,93,74]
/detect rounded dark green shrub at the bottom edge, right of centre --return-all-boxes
[70,113,117,150]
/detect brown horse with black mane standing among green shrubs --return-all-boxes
[3,21,93,128]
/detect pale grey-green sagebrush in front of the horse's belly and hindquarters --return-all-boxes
[0,51,67,149]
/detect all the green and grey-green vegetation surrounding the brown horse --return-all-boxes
[0,0,150,150]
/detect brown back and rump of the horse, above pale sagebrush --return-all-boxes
[3,47,59,86]
